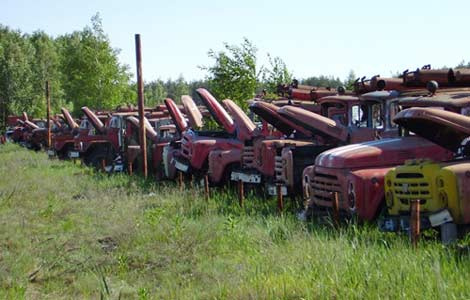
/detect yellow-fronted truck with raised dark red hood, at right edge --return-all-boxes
[379,99,470,243]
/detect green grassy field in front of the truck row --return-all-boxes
[0,145,470,299]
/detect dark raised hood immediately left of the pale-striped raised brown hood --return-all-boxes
[250,101,311,136]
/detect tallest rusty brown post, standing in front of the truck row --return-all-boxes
[135,34,148,178]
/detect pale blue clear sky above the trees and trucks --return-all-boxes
[0,0,470,80]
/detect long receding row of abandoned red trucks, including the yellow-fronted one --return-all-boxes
[7,66,470,242]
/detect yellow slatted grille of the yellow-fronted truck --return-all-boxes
[393,173,431,205]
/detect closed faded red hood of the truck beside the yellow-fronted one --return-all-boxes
[315,136,451,169]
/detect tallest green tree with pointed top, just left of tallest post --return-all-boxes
[58,14,135,112]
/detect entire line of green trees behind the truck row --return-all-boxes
[0,13,350,129]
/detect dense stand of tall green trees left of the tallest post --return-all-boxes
[0,14,135,122]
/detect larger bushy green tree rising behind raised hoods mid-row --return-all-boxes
[201,38,260,109]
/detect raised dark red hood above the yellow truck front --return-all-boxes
[393,107,470,152]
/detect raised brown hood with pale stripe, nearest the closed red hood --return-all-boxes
[278,106,348,142]
